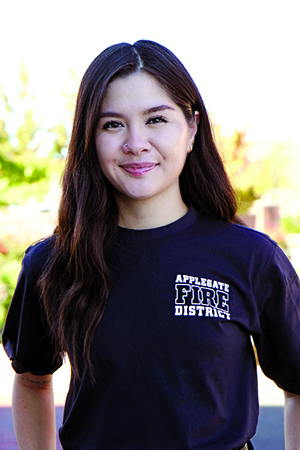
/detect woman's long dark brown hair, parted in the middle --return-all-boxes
[39,40,239,378]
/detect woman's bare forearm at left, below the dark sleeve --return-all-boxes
[12,372,56,450]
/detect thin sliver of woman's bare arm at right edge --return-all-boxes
[284,392,300,450]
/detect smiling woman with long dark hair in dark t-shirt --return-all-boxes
[3,41,300,450]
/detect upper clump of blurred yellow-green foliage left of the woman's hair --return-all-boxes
[0,64,67,206]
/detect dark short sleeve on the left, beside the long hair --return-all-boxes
[2,239,62,375]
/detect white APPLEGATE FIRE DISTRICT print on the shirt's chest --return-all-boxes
[175,275,230,320]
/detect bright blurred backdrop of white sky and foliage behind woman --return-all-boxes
[0,0,300,374]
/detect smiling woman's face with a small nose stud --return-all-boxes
[96,73,198,209]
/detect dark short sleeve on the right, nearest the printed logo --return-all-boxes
[253,247,300,395]
